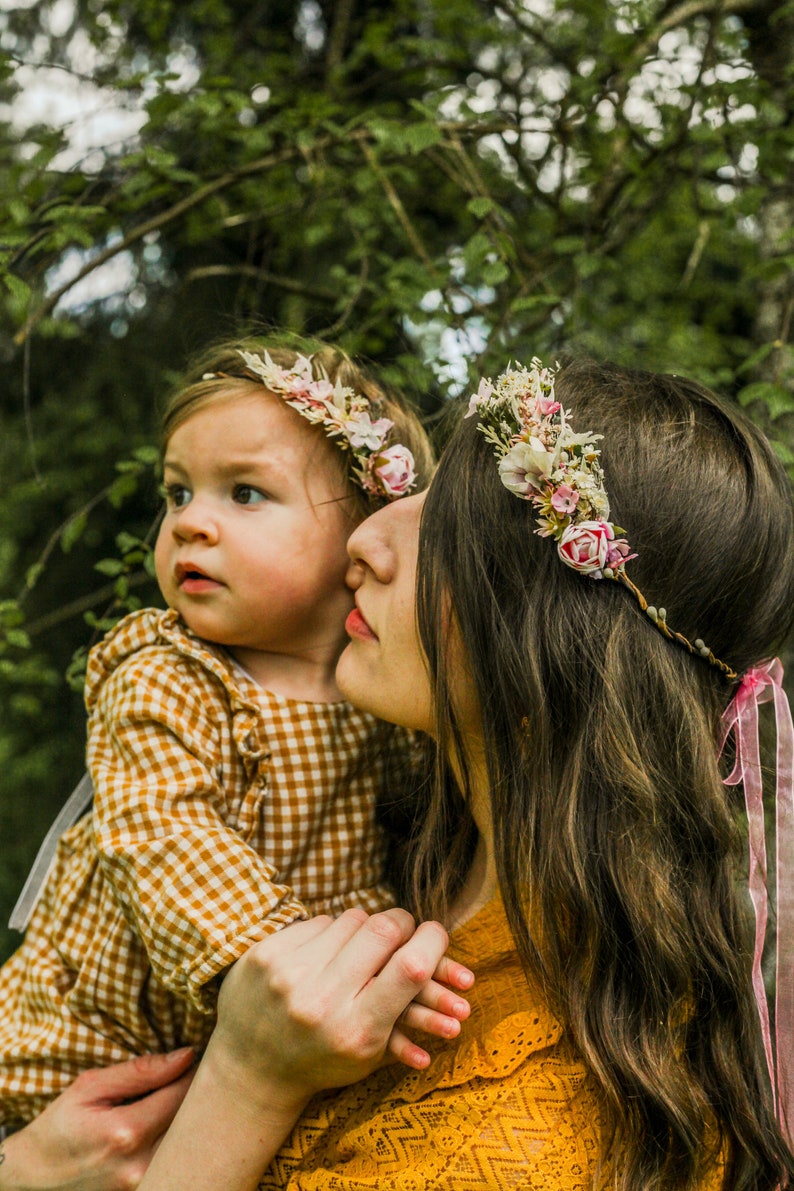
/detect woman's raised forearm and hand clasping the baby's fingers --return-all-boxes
[142,910,459,1191]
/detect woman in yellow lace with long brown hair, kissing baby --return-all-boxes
[0,363,794,1191]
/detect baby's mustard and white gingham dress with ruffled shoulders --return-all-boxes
[0,609,411,1125]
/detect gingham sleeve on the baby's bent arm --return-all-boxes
[88,646,307,1011]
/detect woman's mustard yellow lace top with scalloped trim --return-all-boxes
[260,900,720,1191]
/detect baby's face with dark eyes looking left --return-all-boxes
[155,392,354,663]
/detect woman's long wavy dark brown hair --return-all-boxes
[406,362,794,1191]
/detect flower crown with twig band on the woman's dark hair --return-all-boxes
[465,358,738,680]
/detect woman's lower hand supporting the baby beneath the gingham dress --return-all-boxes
[0,1047,194,1191]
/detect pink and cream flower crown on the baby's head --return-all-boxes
[219,350,417,500]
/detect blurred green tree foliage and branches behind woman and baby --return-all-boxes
[0,0,794,956]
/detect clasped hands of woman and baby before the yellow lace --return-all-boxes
[208,909,461,1104]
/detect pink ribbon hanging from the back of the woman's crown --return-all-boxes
[720,657,794,1146]
